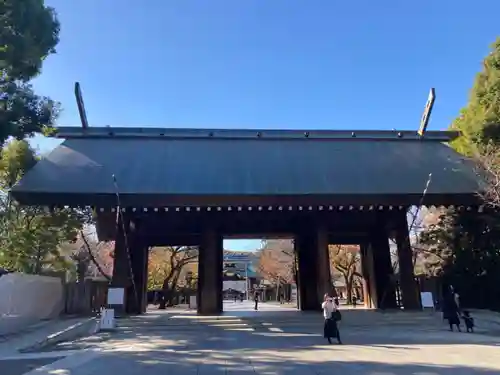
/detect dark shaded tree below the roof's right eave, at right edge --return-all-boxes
[420,209,500,310]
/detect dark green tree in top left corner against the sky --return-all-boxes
[0,0,60,147]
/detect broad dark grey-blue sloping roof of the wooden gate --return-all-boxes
[13,129,478,204]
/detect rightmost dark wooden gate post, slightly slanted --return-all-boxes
[395,212,421,310]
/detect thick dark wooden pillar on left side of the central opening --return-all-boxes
[197,228,223,315]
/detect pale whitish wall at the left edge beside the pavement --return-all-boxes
[0,273,64,335]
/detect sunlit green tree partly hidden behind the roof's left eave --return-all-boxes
[0,140,82,274]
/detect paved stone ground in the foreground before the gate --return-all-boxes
[15,302,500,375]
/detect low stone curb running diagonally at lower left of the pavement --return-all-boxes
[19,317,99,353]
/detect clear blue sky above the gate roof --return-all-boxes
[33,0,500,249]
